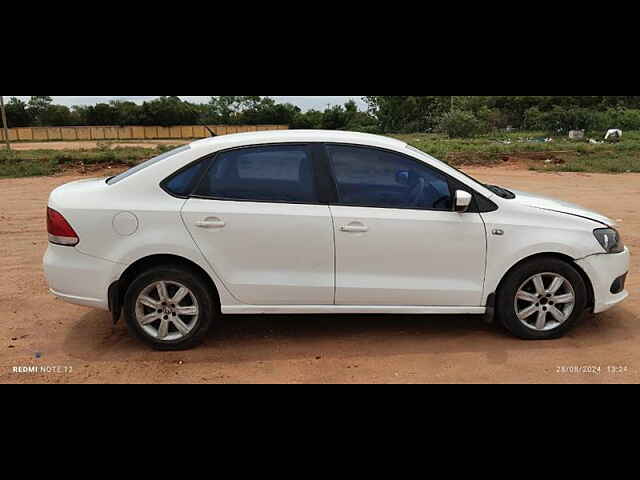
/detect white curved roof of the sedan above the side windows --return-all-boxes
[191,127,407,152]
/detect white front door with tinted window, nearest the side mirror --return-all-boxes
[326,145,486,306]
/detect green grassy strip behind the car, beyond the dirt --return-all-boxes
[0,131,640,178]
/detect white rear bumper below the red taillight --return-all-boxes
[43,244,125,311]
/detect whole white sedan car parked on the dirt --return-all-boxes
[44,131,629,350]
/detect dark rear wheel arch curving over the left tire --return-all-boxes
[109,254,220,323]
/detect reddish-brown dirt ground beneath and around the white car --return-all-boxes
[0,167,640,383]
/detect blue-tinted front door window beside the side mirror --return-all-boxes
[327,145,453,210]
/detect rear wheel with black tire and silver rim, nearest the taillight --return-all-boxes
[124,265,218,350]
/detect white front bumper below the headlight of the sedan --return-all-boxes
[576,248,631,313]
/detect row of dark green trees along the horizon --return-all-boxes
[6,95,640,133]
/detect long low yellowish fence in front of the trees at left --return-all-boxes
[0,125,289,142]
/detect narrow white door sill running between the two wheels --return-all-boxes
[222,305,487,315]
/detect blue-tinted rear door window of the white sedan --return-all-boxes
[196,145,318,203]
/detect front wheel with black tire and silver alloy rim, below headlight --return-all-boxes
[496,257,588,340]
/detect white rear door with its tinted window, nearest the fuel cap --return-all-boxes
[182,145,334,305]
